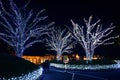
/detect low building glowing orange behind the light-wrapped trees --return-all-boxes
[22,54,103,64]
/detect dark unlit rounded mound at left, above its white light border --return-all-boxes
[0,53,39,78]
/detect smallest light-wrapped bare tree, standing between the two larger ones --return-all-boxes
[46,28,73,60]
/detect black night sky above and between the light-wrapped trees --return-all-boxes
[0,0,120,56]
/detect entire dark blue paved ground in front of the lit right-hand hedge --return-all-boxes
[38,68,120,80]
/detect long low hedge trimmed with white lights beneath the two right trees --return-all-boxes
[51,60,120,70]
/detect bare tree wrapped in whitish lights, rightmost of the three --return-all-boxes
[69,16,119,62]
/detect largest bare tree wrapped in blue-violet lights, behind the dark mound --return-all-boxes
[0,0,52,57]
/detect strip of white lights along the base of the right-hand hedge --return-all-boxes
[50,60,120,70]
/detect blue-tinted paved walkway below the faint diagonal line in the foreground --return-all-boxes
[38,70,107,80]
